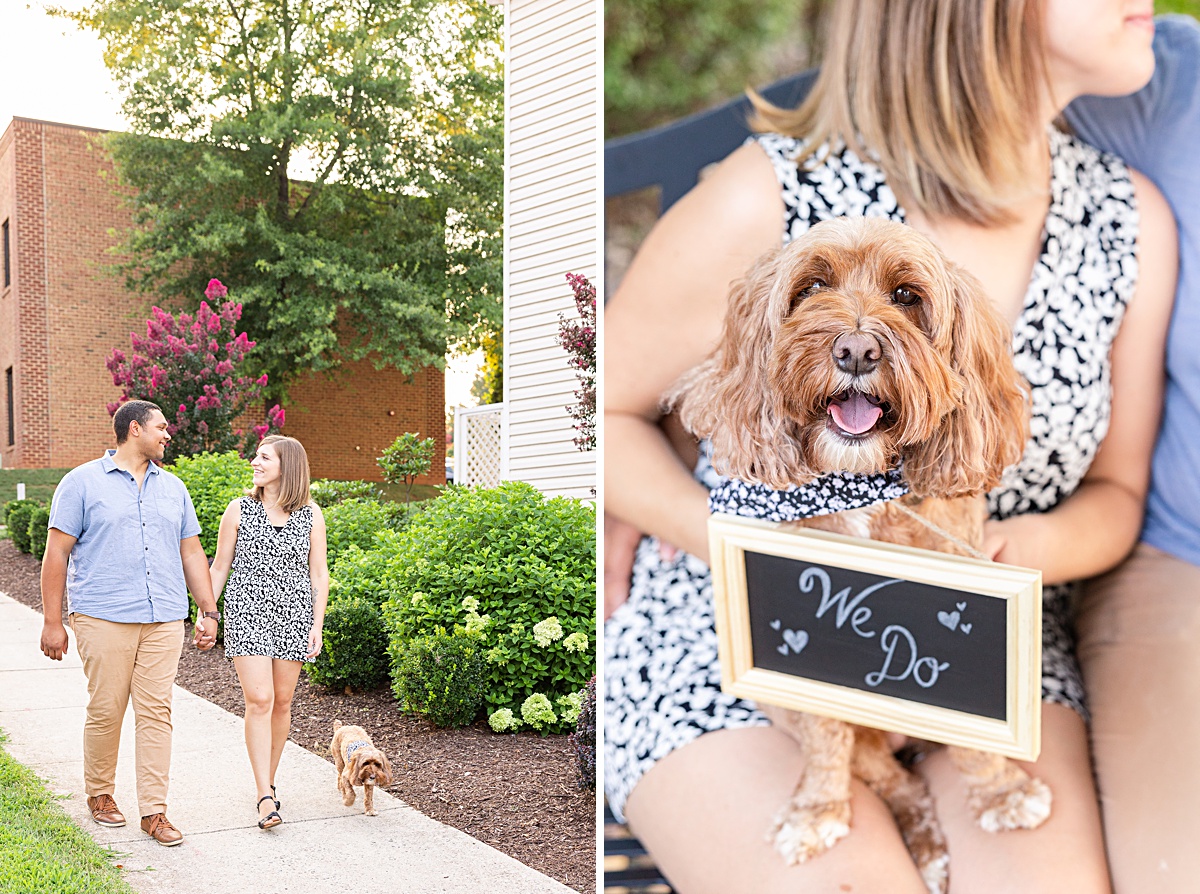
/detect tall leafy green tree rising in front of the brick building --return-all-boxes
[55,0,503,391]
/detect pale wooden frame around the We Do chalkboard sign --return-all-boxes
[708,515,1042,761]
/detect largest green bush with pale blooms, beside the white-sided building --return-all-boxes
[384,481,595,732]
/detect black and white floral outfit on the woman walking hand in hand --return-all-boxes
[224,497,312,661]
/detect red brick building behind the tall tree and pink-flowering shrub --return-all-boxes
[0,118,445,484]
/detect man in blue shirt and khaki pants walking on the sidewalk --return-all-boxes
[41,401,220,847]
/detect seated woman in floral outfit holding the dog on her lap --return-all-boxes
[605,0,1176,894]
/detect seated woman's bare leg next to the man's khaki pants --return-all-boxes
[919,703,1111,894]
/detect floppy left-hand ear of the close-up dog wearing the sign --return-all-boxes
[665,251,816,488]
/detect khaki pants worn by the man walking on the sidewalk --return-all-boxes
[71,614,184,816]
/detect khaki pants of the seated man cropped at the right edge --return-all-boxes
[1076,544,1200,894]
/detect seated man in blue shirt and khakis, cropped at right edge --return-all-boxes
[1067,16,1200,894]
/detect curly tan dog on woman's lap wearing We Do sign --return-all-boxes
[667,218,1051,892]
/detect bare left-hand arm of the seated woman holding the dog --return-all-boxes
[604,145,784,558]
